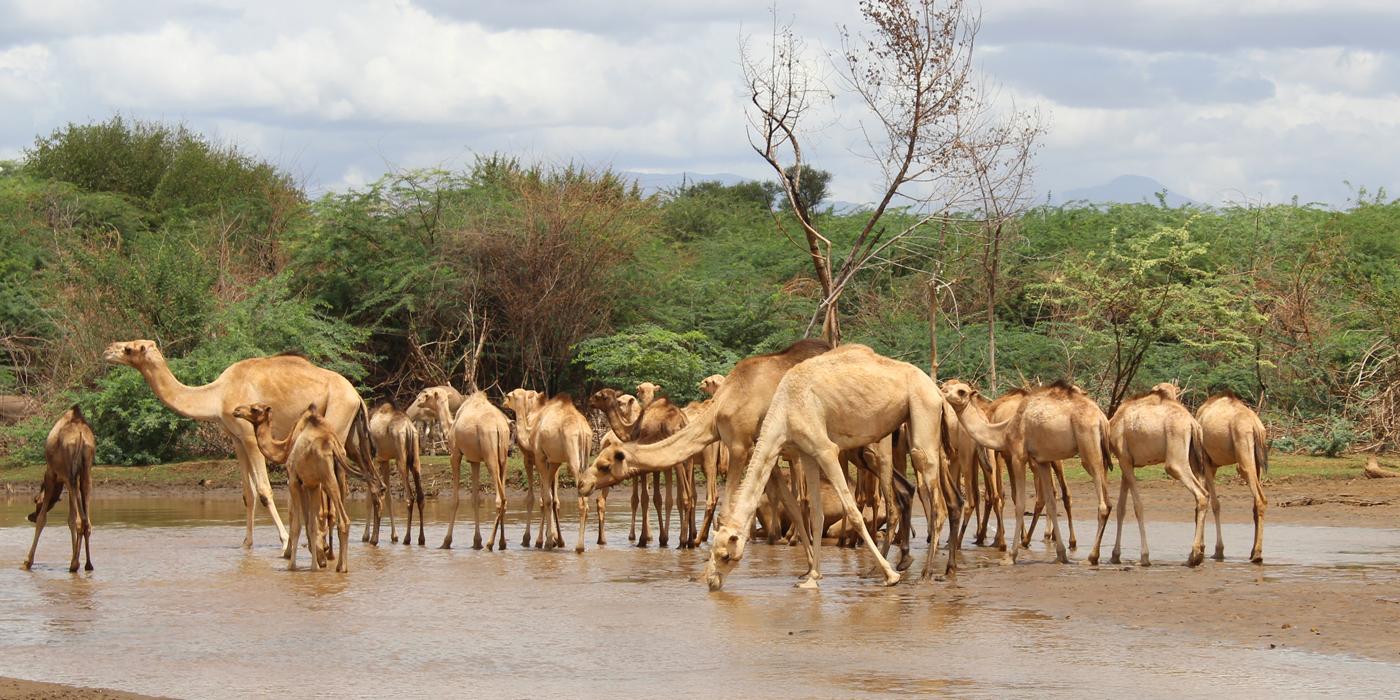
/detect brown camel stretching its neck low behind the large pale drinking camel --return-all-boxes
[580,339,830,551]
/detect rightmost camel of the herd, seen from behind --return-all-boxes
[1196,392,1271,564]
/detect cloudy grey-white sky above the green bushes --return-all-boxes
[0,0,1400,206]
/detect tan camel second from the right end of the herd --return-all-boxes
[1109,382,1211,567]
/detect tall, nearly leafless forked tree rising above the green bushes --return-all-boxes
[742,0,1019,343]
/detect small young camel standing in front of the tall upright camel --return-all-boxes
[234,403,356,573]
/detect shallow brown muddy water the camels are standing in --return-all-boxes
[0,498,1400,697]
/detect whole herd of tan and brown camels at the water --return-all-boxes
[24,340,1268,589]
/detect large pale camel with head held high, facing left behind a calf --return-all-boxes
[102,340,379,547]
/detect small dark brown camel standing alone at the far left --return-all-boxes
[24,405,97,571]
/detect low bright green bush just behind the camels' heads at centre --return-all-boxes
[574,325,738,405]
